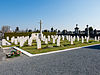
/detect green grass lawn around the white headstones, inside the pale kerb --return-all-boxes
[3,40,100,54]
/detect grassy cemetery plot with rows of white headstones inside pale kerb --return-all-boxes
[2,33,100,55]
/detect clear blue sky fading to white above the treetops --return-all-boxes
[0,0,100,30]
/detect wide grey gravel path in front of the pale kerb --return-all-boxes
[0,45,100,75]
